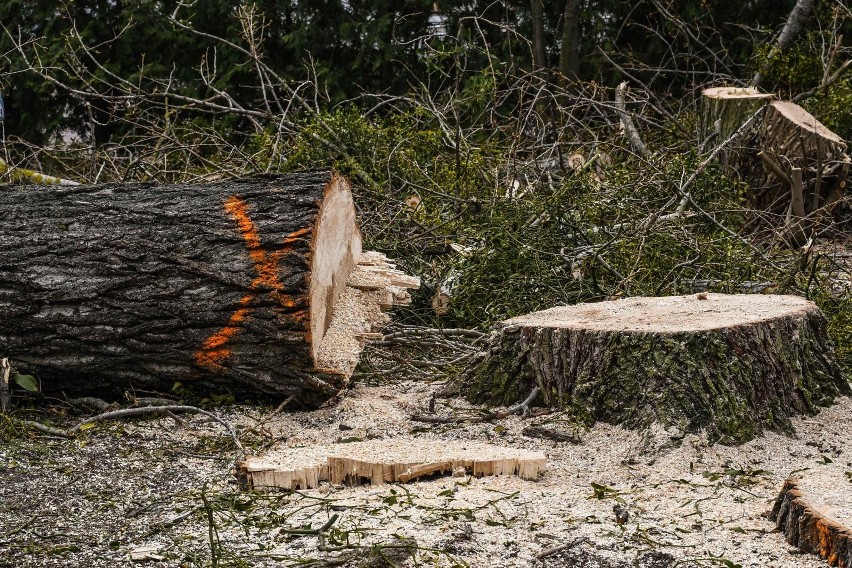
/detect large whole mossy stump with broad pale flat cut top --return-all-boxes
[463,293,852,443]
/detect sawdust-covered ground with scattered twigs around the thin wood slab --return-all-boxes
[0,374,852,568]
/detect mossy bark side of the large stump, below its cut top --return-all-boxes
[466,311,852,443]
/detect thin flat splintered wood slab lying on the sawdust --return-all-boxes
[237,439,546,489]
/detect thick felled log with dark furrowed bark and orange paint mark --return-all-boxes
[0,172,417,406]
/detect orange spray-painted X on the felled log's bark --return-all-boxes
[195,195,310,370]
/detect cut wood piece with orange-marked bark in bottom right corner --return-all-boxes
[769,470,852,568]
